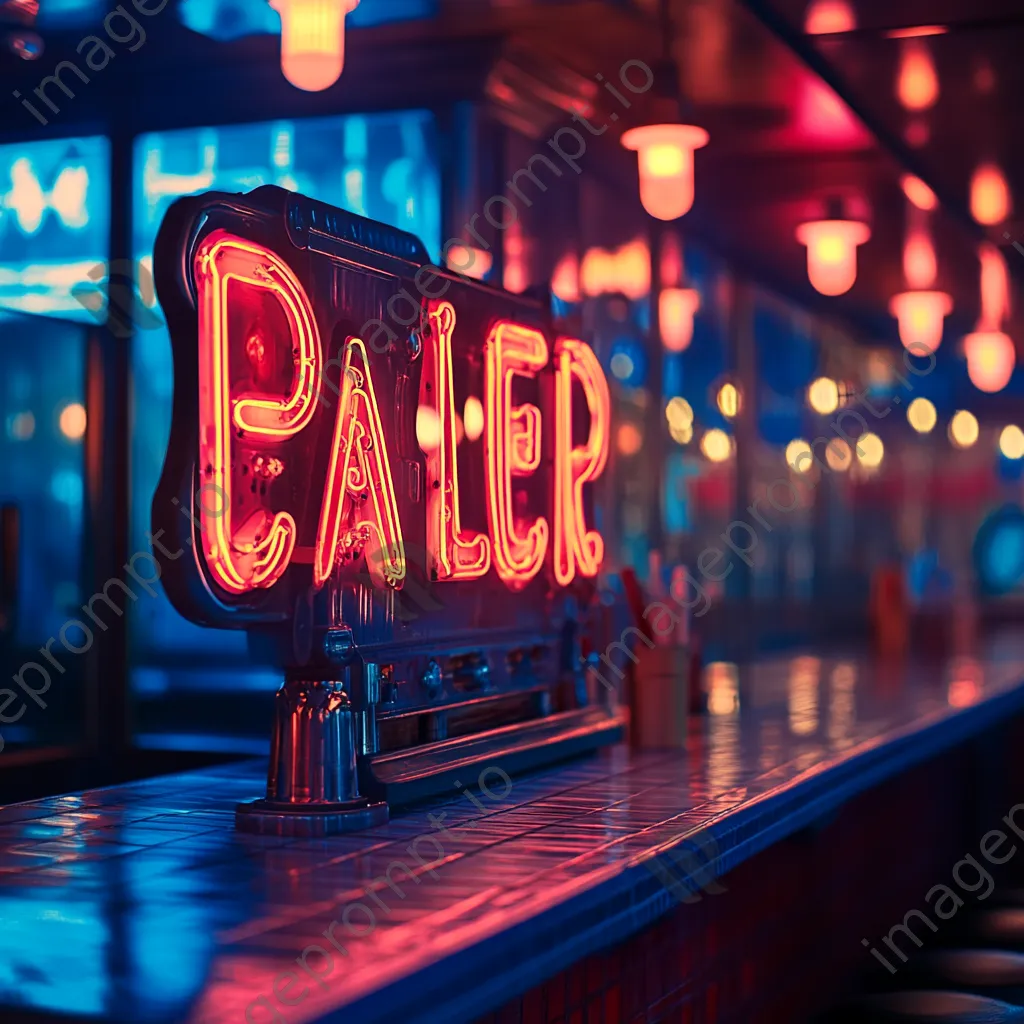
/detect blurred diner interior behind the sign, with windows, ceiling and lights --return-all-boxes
[0,0,1024,796]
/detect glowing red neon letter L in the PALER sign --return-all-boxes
[420,302,490,580]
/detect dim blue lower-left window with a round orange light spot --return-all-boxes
[0,313,86,749]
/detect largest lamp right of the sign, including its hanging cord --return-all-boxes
[622,0,711,220]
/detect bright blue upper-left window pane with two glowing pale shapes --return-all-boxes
[0,136,110,321]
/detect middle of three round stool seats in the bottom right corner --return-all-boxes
[886,949,1024,1006]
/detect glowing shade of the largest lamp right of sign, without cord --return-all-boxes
[622,124,710,220]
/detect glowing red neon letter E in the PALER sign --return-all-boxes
[484,321,550,589]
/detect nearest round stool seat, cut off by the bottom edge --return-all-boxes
[823,991,1024,1024]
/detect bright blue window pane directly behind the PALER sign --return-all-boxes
[132,112,440,675]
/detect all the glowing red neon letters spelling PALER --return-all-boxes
[193,228,610,596]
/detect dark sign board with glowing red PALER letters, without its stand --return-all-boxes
[154,187,610,627]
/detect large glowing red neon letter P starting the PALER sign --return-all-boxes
[194,230,323,594]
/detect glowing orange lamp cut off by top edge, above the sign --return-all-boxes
[269,0,359,92]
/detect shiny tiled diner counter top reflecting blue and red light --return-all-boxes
[0,647,1024,1024]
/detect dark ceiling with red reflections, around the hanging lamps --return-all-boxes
[0,0,1024,407]
